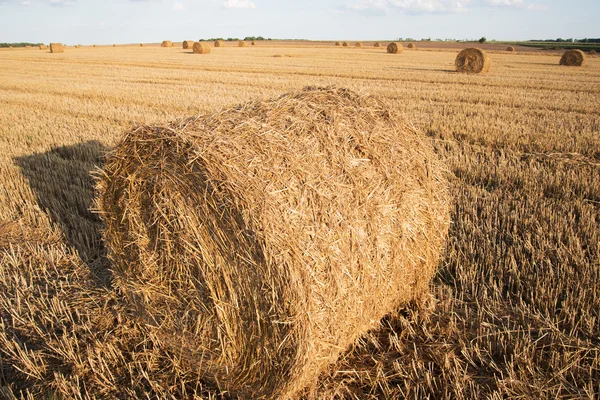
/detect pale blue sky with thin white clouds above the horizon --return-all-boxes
[0,0,600,44]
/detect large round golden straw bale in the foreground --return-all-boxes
[96,88,449,399]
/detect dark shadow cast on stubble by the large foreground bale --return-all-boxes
[13,140,112,286]
